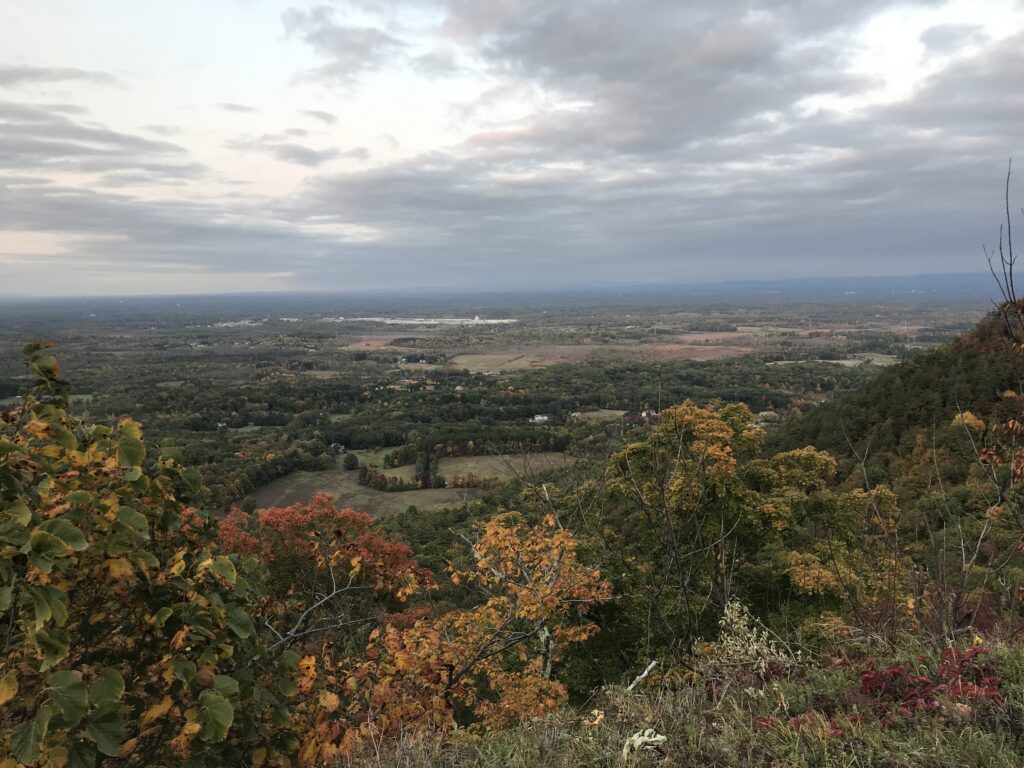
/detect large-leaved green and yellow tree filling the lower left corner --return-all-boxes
[0,344,284,768]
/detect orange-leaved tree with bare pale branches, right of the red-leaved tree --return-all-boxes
[294,514,611,764]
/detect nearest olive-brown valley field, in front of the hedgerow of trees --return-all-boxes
[250,469,481,517]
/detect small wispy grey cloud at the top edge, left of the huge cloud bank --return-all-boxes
[282,5,404,84]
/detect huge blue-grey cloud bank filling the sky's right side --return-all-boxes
[272,2,1024,287]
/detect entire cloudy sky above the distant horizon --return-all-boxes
[0,0,1024,296]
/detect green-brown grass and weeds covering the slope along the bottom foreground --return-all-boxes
[347,645,1024,768]
